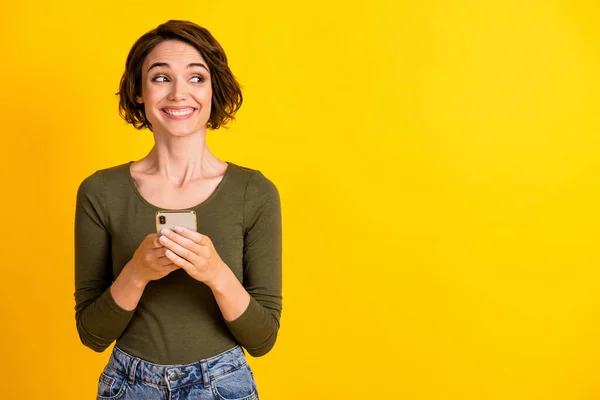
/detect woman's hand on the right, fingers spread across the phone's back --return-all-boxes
[160,227,228,289]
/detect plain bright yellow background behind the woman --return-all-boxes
[0,0,600,400]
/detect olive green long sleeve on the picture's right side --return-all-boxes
[227,171,282,357]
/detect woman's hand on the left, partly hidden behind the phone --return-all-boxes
[128,233,179,286]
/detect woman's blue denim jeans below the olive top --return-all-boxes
[98,346,258,400]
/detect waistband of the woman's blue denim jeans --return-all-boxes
[108,346,246,388]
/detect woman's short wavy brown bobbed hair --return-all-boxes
[117,20,243,130]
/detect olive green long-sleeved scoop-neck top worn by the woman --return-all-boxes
[75,162,282,364]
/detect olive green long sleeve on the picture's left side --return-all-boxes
[75,172,133,352]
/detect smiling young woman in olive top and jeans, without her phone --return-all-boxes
[75,21,281,400]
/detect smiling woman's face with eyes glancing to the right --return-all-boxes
[136,40,212,136]
